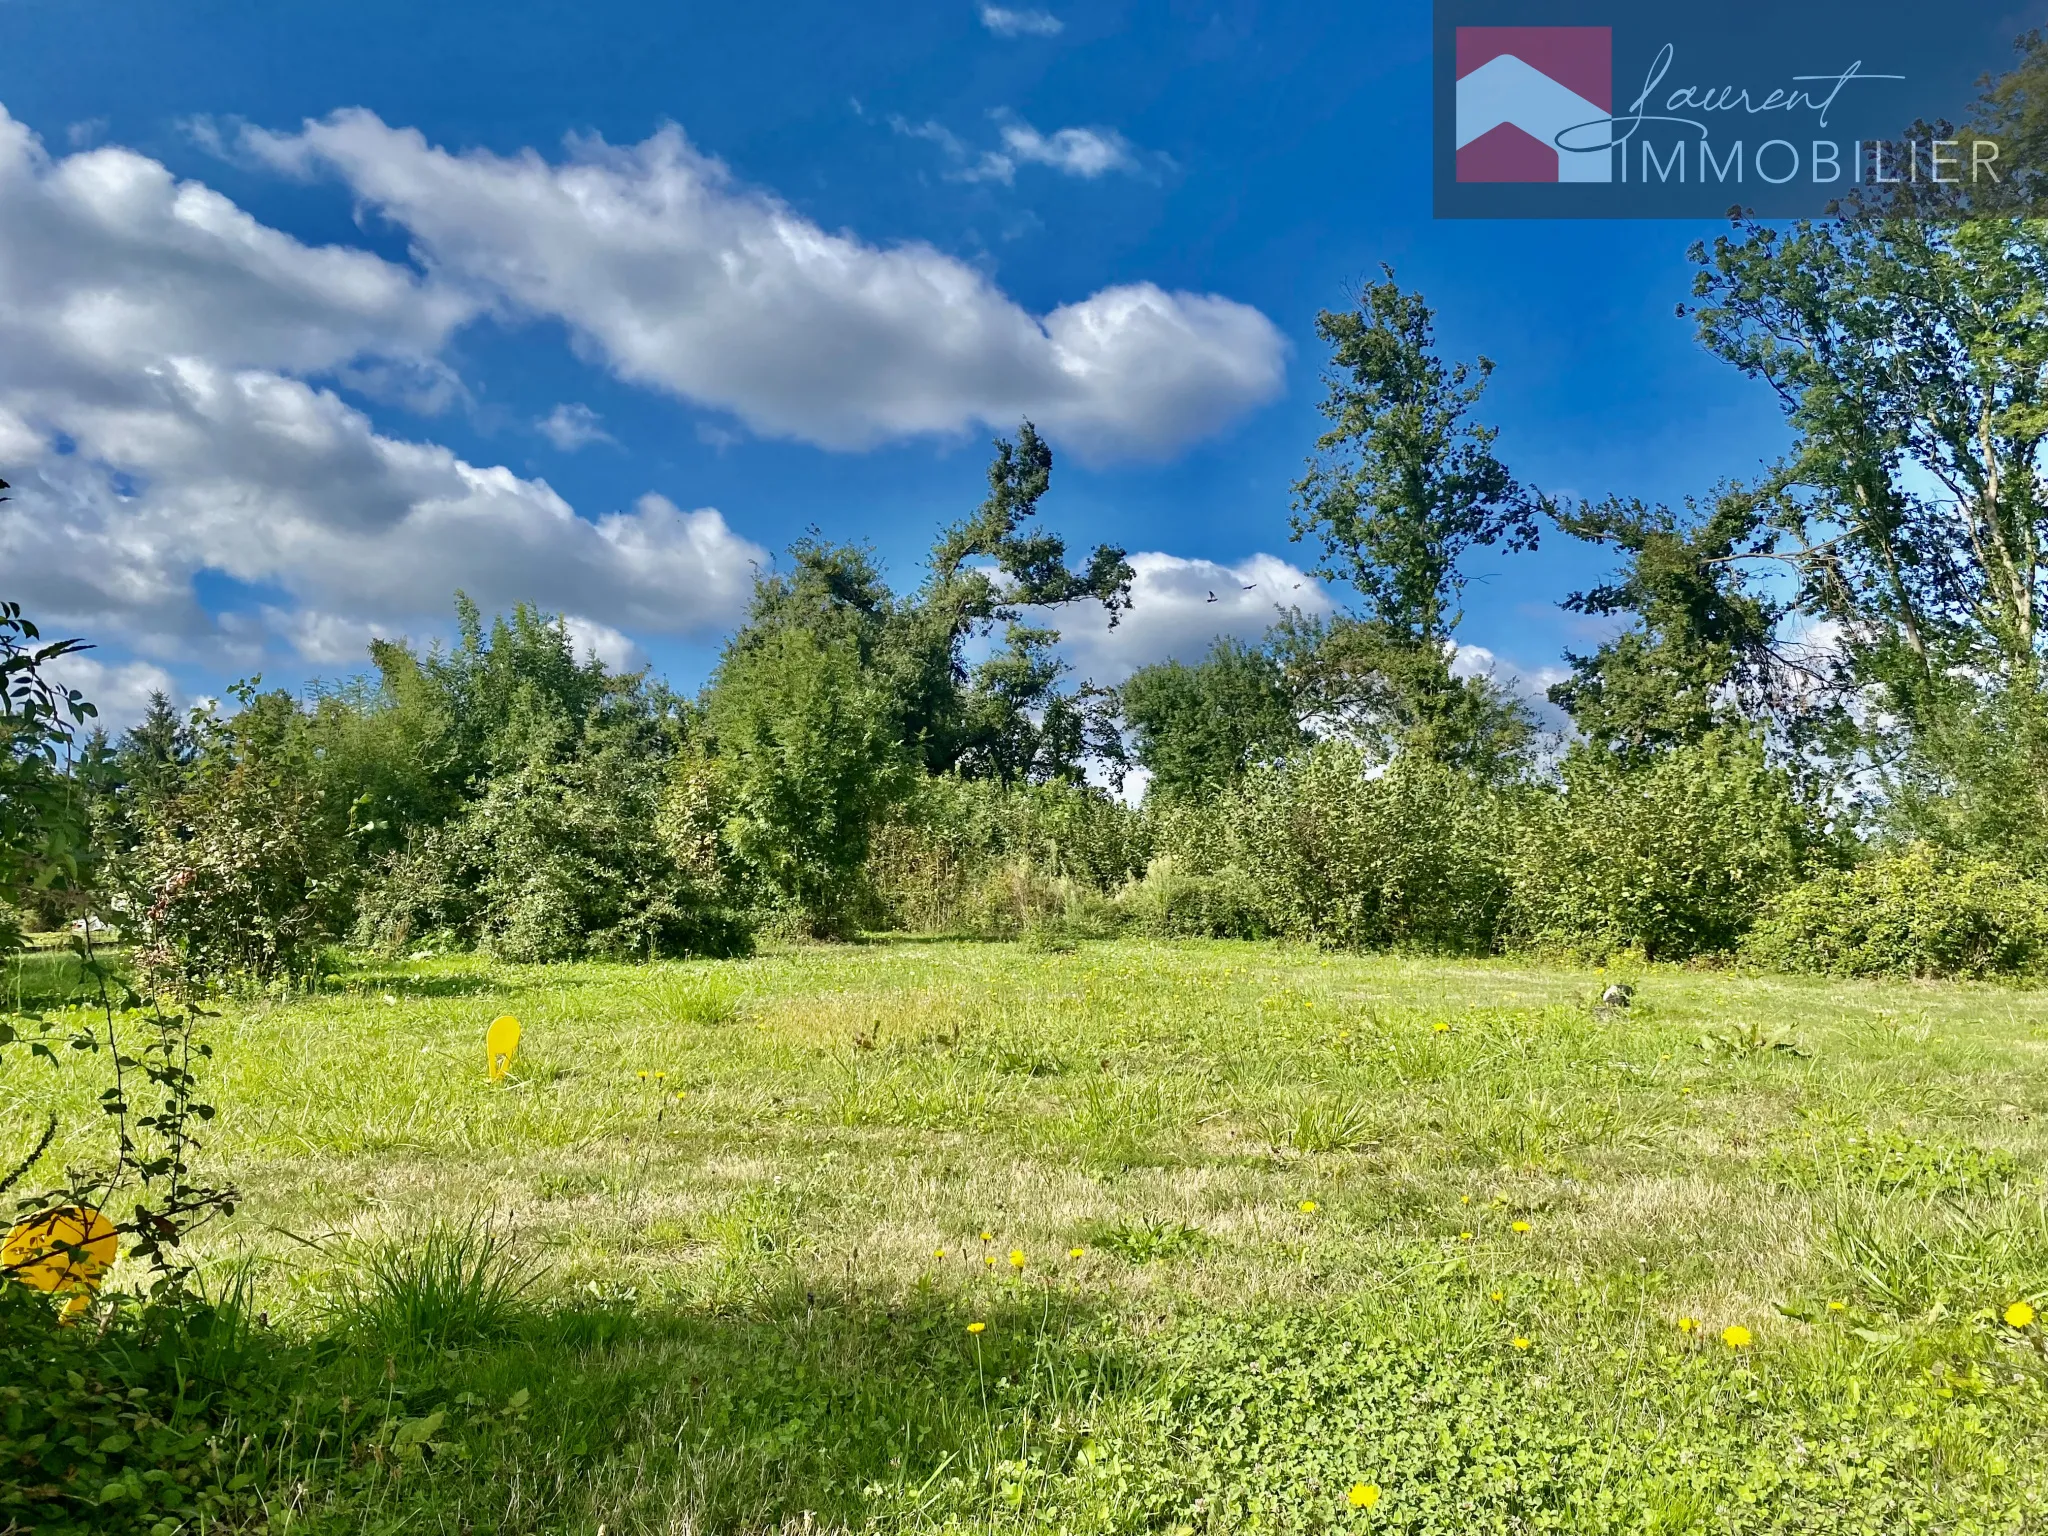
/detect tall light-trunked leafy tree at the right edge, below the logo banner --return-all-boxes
[1694,219,2048,850]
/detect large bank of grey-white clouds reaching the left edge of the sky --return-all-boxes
[0,111,762,663]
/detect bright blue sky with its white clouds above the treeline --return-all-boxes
[0,0,1784,729]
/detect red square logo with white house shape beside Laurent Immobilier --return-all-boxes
[1456,27,1614,182]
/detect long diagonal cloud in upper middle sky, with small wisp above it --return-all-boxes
[244,111,1286,457]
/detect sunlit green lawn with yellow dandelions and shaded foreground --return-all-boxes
[12,942,2048,1536]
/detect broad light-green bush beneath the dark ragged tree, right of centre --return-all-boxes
[1507,735,1823,961]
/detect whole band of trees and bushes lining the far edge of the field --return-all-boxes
[12,207,2048,985]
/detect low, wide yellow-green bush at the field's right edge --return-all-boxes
[1745,844,2048,977]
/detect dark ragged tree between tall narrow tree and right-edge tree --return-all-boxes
[1550,487,1788,752]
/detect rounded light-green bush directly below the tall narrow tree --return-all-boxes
[1231,741,1509,952]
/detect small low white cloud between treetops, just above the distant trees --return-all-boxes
[1051,551,1331,684]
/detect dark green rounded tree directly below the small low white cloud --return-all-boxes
[1118,637,1307,799]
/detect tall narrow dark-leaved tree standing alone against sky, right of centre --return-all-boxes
[1288,268,1546,762]
